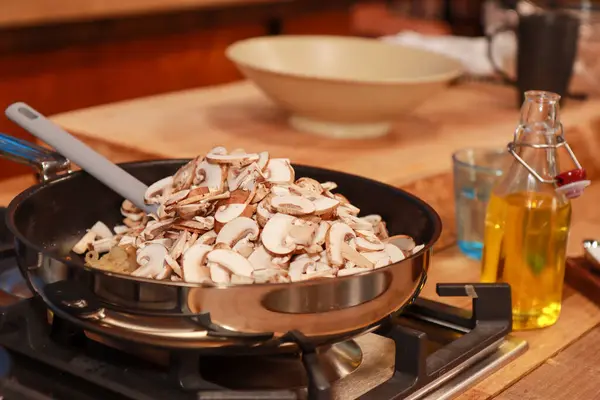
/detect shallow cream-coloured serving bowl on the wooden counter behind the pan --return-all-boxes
[226,35,462,138]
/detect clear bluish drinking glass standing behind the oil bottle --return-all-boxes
[452,148,511,260]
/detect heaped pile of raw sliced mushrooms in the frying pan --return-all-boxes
[73,147,423,284]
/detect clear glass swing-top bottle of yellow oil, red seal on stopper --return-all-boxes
[481,91,589,330]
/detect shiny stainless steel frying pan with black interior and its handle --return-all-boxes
[0,134,441,349]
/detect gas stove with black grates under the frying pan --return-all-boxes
[0,210,527,400]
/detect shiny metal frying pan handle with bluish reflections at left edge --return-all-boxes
[0,133,71,183]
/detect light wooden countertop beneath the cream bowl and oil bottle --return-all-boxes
[9,82,600,400]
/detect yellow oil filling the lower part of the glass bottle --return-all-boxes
[481,192,571,330]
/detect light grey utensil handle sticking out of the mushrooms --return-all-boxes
[6,102,156,212]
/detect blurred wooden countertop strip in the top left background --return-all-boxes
[0,0,284,27]
